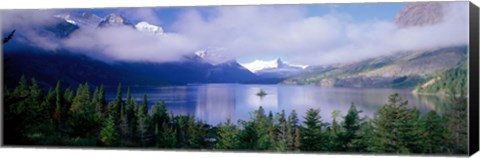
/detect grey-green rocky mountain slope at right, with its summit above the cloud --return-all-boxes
[283,2,468,88]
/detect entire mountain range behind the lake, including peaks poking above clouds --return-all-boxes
[3,3,468,92]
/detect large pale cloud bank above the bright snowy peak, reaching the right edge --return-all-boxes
[171,3,468,65]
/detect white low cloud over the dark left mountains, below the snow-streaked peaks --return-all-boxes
[63,26,197,62]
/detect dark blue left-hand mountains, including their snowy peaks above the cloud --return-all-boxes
[4,13,296,87]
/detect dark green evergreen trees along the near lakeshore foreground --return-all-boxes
[3,76,468,154]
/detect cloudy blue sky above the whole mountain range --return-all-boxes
[1,2,468,65]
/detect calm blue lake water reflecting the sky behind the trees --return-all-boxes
[106,84,446,125]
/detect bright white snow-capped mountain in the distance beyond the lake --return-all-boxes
[242,58,308,73]
